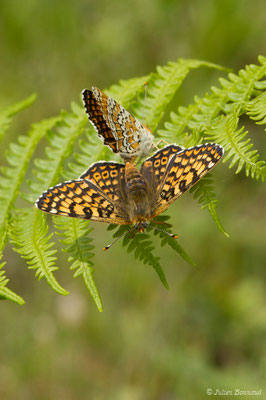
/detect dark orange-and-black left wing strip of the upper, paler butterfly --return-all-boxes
[82,89,118,153]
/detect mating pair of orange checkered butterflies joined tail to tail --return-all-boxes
[36,88,223,244]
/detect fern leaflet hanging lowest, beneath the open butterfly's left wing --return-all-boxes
[54,217,103,311]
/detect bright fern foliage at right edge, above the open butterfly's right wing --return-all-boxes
[160,56,266,181]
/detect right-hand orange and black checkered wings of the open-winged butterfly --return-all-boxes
[142,144,223,218]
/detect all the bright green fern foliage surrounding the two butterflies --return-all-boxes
[0,57,266,311]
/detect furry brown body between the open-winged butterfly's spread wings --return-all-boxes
[125,162,150,224]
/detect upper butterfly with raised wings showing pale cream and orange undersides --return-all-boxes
[82,87,154,161]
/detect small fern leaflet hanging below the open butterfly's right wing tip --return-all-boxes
[190,174,229,237]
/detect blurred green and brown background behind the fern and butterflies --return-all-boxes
[0,0,266,400]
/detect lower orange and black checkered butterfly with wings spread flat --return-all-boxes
[36,143,223,245]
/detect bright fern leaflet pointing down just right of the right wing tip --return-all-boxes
[206,112,266,181]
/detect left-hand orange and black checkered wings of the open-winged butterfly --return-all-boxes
[36,163,130,225]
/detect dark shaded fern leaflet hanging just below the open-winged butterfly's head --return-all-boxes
[107,224,169,289]
